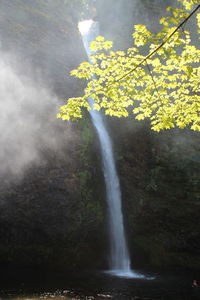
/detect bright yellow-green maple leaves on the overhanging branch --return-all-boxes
[57,0,200,132]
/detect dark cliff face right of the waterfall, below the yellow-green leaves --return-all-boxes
[108,118,200,269]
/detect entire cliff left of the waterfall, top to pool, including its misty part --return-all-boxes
[0,0,105,268]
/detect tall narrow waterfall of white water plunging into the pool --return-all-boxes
[79,20,144,278]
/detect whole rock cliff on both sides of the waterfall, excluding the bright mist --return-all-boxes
[0,0,200,268]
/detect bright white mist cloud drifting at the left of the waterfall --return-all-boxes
[0,53,72,177]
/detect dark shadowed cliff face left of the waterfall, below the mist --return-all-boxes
[0,132,105,270]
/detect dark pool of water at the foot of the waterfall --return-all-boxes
[0,269,200,300]
